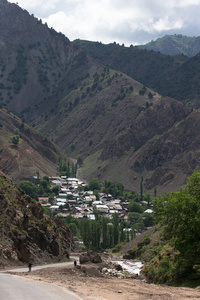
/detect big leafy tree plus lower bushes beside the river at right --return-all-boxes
[145,171,200,286]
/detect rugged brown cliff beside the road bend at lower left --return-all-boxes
[0,171,73,267]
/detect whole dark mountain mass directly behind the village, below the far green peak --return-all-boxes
[0,0,200,193]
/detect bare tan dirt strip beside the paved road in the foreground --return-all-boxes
[15,267,200,300]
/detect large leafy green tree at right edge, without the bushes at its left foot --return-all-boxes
[154,172,200,277]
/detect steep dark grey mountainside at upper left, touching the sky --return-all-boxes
[0,0,99,119]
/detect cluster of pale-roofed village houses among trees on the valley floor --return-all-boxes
[38,176,153,220]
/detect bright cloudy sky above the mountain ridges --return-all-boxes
[8,0,200,46]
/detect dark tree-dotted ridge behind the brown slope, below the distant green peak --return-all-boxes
[74,40,200,108]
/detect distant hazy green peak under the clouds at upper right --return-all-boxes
[138,34,200,57]
